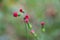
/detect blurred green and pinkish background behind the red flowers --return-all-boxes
[0,0,60,40]
